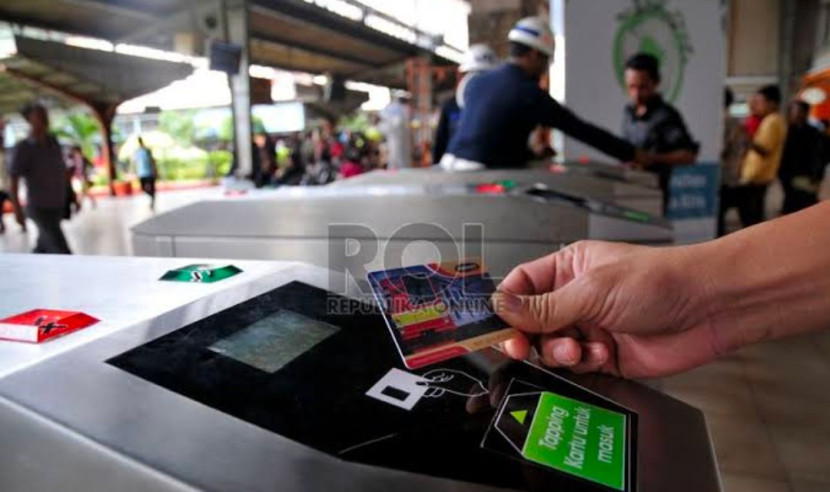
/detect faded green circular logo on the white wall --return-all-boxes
[613,0,693,102]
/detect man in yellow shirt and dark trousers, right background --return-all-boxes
[738,85,787,227]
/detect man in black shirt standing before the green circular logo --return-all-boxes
[623,53,700,212]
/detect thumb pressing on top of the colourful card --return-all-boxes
[492,285,588,333]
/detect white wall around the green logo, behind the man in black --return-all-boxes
[551,0,725,162]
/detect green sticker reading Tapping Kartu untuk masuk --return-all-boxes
[522,392,626,490]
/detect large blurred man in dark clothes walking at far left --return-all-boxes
[8,103,72,255]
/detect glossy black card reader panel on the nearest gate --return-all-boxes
[108,283,637,492]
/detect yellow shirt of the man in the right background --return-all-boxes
[741,112,787,185]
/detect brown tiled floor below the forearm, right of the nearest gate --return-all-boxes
[662,333,830,492]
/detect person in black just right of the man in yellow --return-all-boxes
[778,101,826,215]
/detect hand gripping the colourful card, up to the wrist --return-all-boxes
[493,241,721,378]
